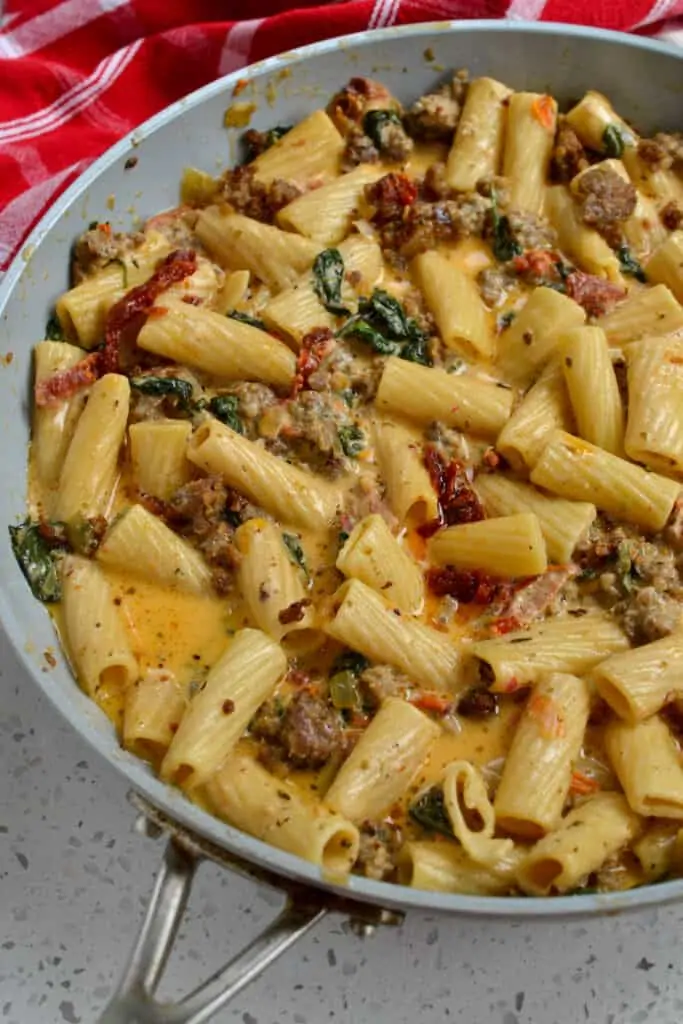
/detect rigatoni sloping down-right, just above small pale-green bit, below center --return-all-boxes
[325,580,460,690]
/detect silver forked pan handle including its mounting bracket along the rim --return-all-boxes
[97,794,403,1024]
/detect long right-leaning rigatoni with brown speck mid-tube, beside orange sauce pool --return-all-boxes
[161,630,287,791]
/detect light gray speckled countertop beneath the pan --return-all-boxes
[0,622,683,1024]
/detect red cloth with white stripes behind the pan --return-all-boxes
[0,0,683,272]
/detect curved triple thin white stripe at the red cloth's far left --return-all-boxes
[0,39,143,142]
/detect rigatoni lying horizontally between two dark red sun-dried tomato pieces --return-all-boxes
[428,512,548,578]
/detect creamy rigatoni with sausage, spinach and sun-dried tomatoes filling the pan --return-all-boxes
[17,75,683,897]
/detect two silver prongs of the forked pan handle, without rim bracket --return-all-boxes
[99,839,330,1024]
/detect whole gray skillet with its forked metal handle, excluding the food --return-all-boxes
[0,22,683,1024]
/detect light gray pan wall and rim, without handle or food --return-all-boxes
[0,22,683,916]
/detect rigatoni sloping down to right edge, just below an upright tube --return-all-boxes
[531,430,680,532]
